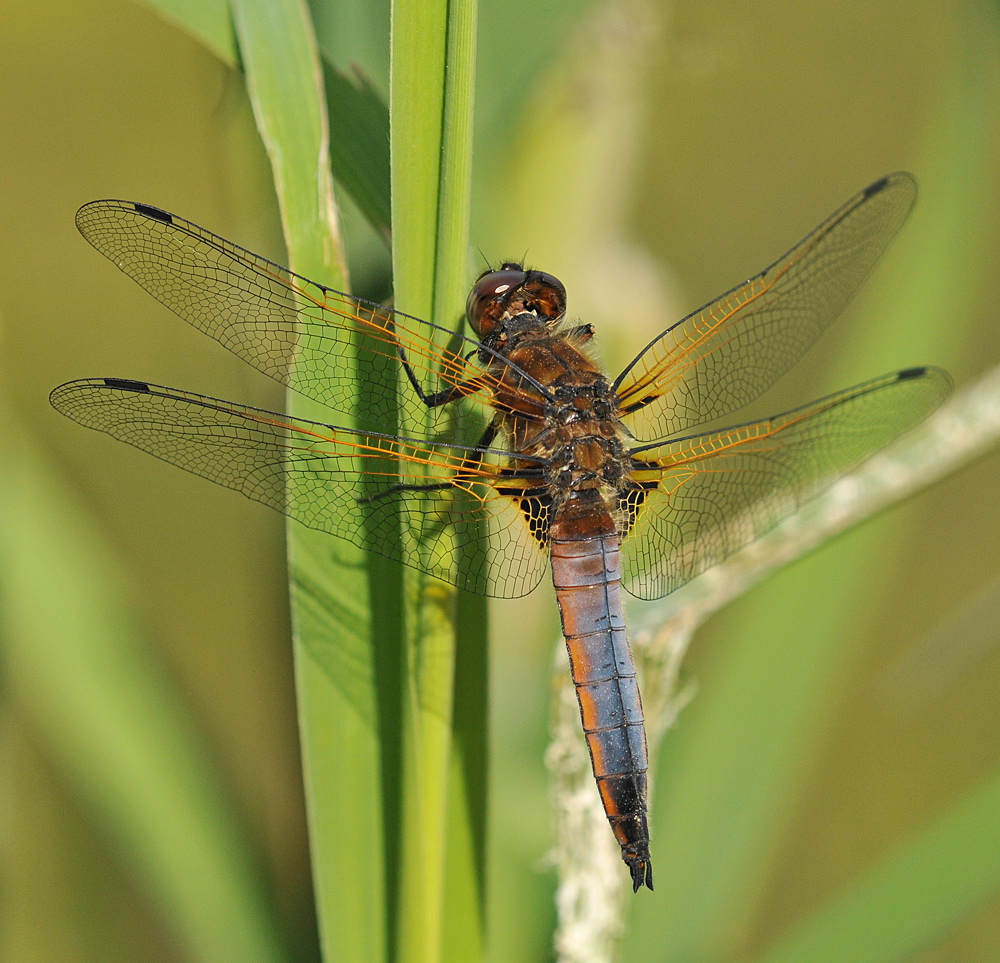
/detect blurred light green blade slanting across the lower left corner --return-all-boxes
[0,412,288,963]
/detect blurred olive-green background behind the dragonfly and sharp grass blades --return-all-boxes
[0,0,1000,963]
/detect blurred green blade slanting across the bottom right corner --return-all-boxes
[756,760,1000,963]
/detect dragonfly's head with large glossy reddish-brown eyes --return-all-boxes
[465,261,566,338]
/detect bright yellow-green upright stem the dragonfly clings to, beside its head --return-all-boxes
[390,0,485,961]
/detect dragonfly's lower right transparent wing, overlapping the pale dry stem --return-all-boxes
[622,368,951,599]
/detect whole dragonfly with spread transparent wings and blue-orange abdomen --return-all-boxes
[51,173,951,892]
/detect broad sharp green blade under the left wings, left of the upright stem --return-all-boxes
[233,0,390,963]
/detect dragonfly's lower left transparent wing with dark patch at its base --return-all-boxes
[50,378,548,598]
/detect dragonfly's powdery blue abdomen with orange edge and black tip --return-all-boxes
[551,490,653,890]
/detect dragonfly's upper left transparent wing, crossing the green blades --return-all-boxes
[76,200,537,432]
